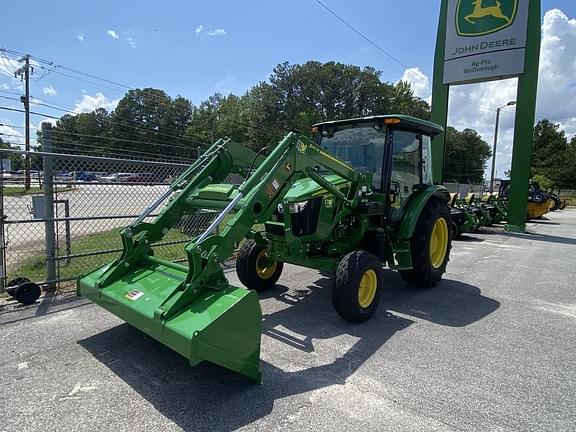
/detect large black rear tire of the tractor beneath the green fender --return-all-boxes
[400,199,452,287]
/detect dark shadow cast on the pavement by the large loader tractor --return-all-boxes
[79,272,499,431]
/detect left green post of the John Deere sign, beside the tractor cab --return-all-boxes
[431,1,450,183]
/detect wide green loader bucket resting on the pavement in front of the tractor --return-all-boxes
[77,263,262,382]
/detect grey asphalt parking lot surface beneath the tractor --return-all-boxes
[0,209,576,432]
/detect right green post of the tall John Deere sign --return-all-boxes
[505,0,541,233]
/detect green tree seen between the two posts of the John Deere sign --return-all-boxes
[444,127,492,183]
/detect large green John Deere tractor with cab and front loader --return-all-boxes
[77,115,451,382]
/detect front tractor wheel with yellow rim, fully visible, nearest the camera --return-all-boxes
[332,251,383,323]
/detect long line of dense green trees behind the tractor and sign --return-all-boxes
[16,61,576,187]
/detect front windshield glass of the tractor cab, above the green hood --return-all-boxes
[320,123,385,190]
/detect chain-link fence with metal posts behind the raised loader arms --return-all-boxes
[0,150,241,287]
